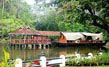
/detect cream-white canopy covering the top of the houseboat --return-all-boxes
[62,32,102,41]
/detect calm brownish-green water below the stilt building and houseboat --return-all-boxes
[0,43,109,60]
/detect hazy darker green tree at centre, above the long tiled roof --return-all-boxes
[35,10,59,31]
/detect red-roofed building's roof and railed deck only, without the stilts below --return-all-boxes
[10,26,60,44]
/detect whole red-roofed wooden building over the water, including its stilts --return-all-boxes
[10,26,59,49]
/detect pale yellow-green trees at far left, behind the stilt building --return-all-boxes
[0,0,32,37]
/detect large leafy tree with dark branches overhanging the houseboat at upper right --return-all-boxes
[57,0,109,34]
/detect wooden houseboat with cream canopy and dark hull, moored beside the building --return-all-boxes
[58,32,106,46]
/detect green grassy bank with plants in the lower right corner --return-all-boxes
[66,50,109,66]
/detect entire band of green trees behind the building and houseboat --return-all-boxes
[0,0,109,39]
